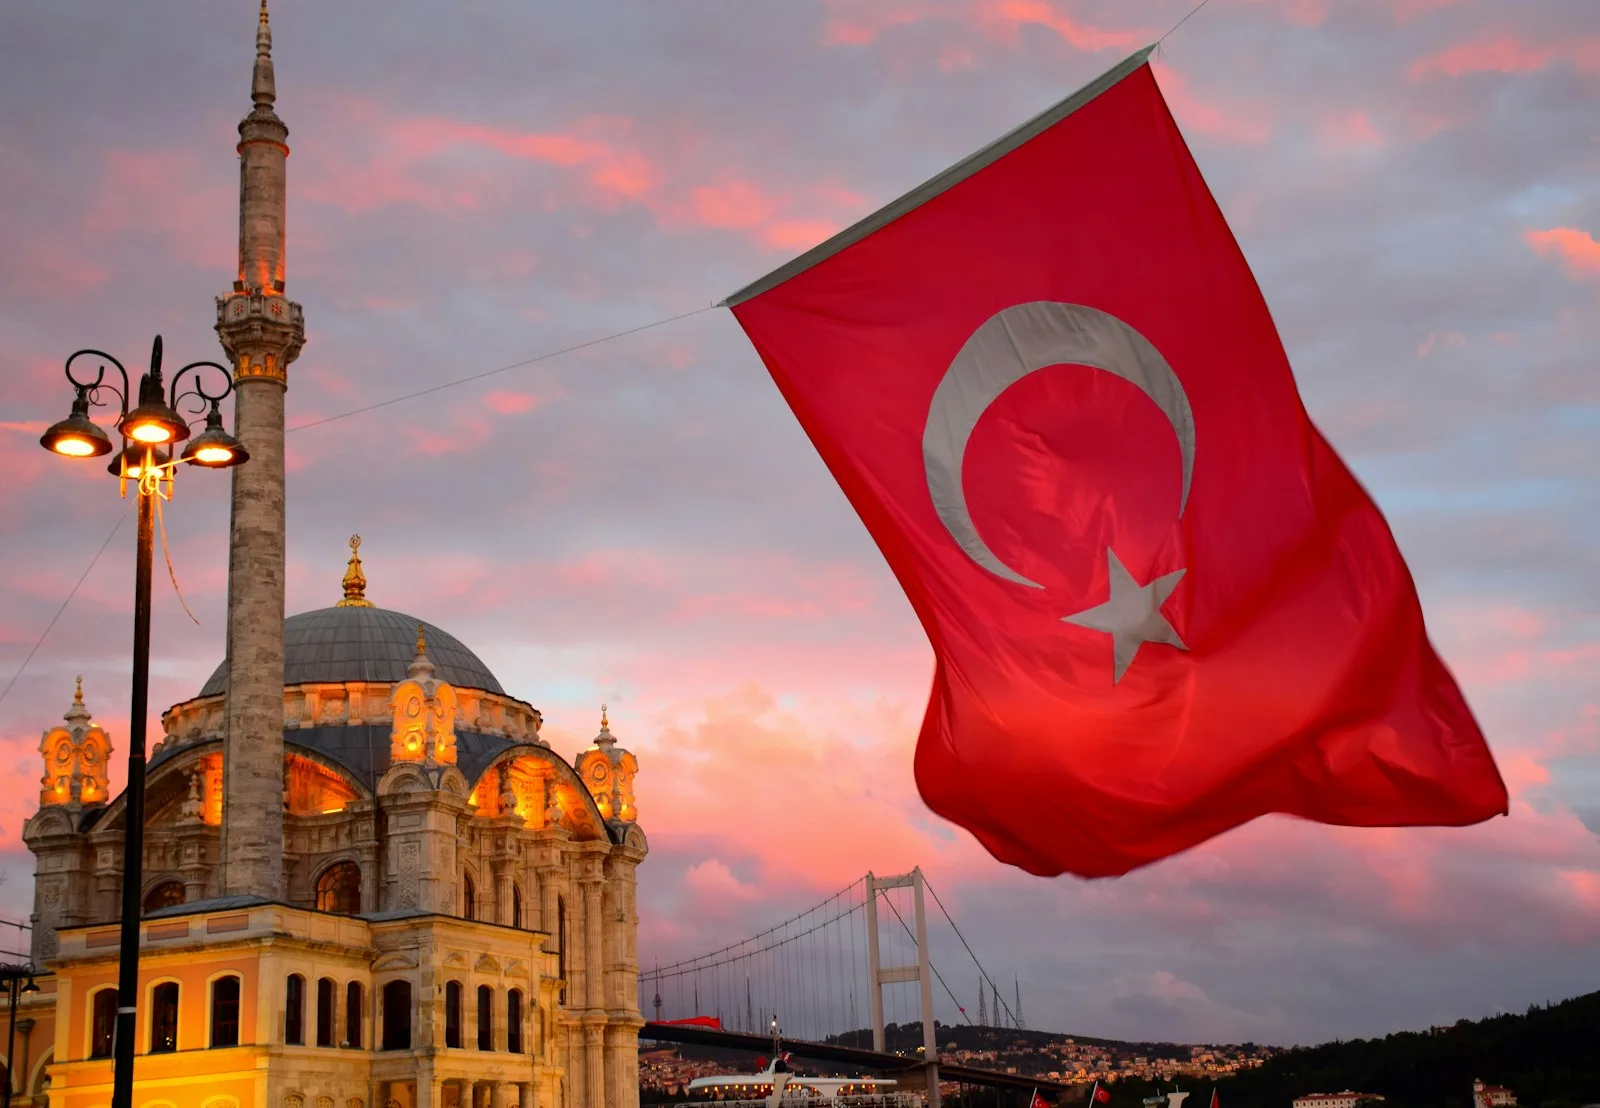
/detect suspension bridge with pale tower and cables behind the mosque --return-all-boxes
[638,868,1077,1108]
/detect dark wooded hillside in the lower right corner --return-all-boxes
[1110,993,1600,1108]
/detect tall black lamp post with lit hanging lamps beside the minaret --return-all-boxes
[38,335,250,1108]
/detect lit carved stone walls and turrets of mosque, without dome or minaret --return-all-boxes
[19,637,648,1108]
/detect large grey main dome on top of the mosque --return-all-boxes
[200,605,506,697]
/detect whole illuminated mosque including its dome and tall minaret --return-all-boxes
[5,8,648,1108]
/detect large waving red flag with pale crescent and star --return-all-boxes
[726,51,1506,876]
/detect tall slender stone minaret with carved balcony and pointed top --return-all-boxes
[216,0,306,898]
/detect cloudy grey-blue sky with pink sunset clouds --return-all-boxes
[0,0,1600,1042]
